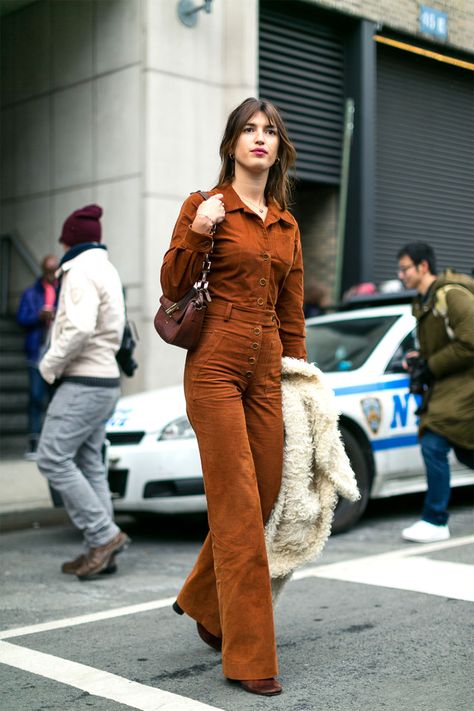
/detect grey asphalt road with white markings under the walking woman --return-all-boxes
[0,488,474,711]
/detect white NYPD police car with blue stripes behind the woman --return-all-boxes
[107,304,474,531]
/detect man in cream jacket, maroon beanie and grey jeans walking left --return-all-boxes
[37,205,130,580]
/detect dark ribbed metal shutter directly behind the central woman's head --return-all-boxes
[259,3,344,184]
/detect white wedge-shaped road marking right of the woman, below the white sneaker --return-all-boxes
[292,536,474,602]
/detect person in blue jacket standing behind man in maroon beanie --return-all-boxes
[16,254,59,459]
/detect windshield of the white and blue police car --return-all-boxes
[306,316,398,372]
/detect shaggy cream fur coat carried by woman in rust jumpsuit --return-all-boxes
[265,358,359,597]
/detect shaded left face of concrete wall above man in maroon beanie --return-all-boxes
[1,0,143,368]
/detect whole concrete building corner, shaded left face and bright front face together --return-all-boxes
[0,0,258,391]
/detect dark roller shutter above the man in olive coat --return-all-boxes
[374,47,474,281]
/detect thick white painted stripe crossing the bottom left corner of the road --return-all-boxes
[0,642,223,711]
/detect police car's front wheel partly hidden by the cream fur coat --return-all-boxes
[332,427,370,533]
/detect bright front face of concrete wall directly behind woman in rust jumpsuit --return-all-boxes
[141,0,258,387]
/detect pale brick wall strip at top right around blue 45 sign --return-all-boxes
[308,0,474,52]
